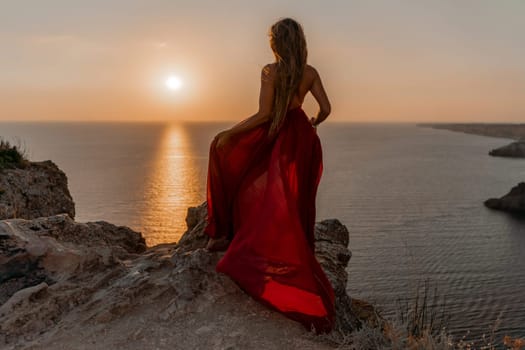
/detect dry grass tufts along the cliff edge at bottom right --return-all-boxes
[310,280,525,350]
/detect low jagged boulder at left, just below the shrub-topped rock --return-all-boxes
[0,214,146,304]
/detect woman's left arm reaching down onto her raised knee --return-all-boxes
[217,64,275,147]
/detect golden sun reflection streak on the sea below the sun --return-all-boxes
[141,124,205,246]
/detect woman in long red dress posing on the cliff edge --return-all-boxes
[205,18,335,333]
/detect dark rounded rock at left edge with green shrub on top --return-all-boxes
[0,160,75,219]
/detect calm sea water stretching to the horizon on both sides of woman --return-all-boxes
[0,123,525,337]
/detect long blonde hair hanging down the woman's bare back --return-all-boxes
[269,18,308,136]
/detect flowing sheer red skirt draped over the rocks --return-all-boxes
[205,107,335,333]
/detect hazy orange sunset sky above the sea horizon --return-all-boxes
[0,0,525,122]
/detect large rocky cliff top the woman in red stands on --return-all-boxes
[0,204,379,349]
